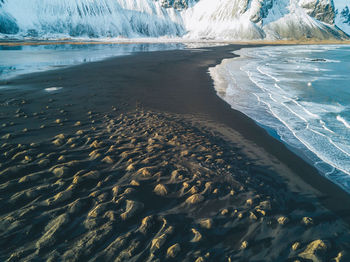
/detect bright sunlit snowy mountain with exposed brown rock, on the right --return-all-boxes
[184,0,347,40]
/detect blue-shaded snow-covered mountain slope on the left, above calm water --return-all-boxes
[0,0,184,38]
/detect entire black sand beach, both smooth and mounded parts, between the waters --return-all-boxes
[0,45,350,262]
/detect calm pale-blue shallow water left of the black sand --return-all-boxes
[0,43,184,81]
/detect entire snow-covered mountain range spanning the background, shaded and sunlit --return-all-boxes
[0,0,350,40]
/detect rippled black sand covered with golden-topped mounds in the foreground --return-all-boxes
[0,110,350,262]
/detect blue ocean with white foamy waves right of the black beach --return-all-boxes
[209,45,350,192]
